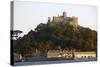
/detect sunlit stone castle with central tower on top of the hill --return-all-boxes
[48,12,78,30]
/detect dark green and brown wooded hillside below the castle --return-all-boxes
[12,23,97,55]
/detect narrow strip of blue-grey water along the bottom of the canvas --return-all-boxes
[14,58,97,66]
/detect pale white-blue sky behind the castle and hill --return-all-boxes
[14,1,98,34]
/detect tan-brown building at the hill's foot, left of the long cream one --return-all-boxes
[47,50,73,59]
